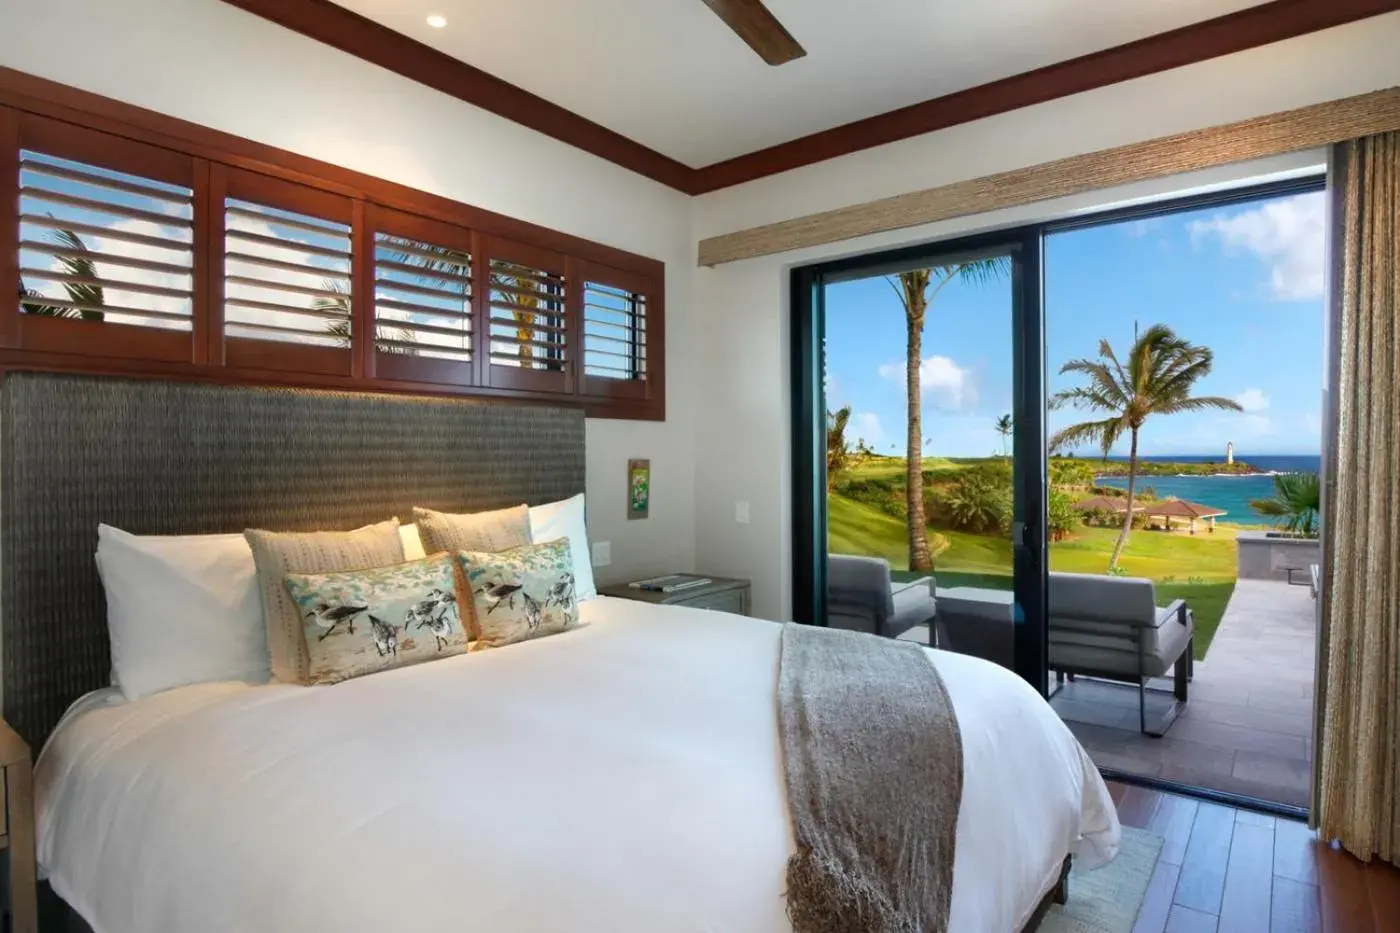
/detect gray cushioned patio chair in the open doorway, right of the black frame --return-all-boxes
[1050,573,1196,737]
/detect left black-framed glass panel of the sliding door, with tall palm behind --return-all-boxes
[792,225,1047,692]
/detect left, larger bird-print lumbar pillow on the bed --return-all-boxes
[286,553,466,684]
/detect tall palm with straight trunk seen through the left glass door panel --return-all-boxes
[886,256,1011,570]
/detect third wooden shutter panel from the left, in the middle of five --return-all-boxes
[368,207,477,385]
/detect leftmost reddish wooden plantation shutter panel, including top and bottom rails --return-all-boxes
[4,115,196,361]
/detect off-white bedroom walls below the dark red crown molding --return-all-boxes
[0,0,1400,618]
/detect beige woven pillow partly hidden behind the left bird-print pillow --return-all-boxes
[244,518,403,684]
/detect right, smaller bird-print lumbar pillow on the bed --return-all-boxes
[456,538,578,650]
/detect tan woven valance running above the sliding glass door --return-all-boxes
[699,87,1400,266]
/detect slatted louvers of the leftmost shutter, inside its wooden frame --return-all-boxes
[20,150,195,332]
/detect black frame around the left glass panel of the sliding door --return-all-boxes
[791,227,1050,695]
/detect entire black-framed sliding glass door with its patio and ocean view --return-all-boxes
[792,177,1326,813]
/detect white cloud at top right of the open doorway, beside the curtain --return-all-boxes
[1190,193,1327,301]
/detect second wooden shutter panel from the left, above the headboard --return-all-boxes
[217,168,357,375]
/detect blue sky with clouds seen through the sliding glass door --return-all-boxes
[826,193,1326,457]
